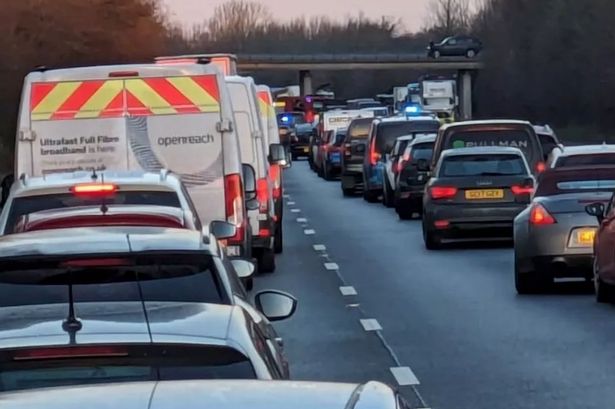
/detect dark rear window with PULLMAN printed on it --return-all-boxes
[442,129,537,162]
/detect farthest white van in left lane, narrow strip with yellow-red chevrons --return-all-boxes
[256,85,290,253]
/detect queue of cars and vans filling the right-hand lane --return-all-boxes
[308,101,615,303]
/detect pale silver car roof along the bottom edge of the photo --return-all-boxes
[0,380,396,409]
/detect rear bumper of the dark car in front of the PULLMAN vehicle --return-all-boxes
[424,204,527,240]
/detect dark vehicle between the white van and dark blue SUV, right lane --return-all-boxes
[340,118,374,196]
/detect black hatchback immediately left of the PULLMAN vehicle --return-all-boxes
[394,134,436,220]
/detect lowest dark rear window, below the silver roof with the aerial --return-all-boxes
[0,345,256,392]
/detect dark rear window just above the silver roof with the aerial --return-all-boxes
[0,253,229,308]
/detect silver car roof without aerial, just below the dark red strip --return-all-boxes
[0,226,210,260]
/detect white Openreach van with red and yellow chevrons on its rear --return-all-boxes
[15,64,251,256]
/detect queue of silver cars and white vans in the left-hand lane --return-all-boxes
[0,54,418,409]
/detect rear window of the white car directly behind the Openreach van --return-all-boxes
[4,190,181,234]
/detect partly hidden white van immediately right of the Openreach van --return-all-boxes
[225,75,275,272]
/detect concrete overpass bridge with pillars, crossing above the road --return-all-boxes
[237,54,483,119]
